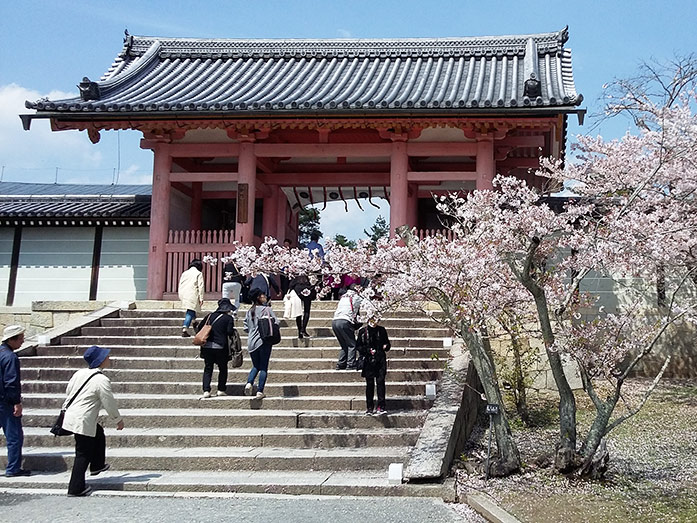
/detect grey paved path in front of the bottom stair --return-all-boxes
[0,489,483,523]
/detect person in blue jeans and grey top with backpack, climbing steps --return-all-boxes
[244,288,279,399]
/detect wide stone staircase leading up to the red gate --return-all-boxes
[6,302,452,498]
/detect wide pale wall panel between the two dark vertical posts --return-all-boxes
[14,227,94,306]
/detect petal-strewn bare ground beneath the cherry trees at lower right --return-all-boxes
[456,380,697,522]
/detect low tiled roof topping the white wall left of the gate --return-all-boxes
[0,182,151,220]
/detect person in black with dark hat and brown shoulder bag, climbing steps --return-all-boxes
[196,298,235,398]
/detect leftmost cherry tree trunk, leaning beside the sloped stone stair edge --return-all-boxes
[462,328,520,476]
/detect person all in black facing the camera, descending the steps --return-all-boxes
[356,318,391,414]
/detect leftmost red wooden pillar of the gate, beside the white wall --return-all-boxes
[147,143,172,300]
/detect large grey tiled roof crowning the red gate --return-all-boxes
[26,29,583,116]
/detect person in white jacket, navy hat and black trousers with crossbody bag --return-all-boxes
[63,345,123,496]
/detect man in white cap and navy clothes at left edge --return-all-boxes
[0,325,31,477]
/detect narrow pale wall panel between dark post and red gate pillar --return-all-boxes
[97,227,149,301]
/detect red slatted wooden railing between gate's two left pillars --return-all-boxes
[165,231,235,294]
